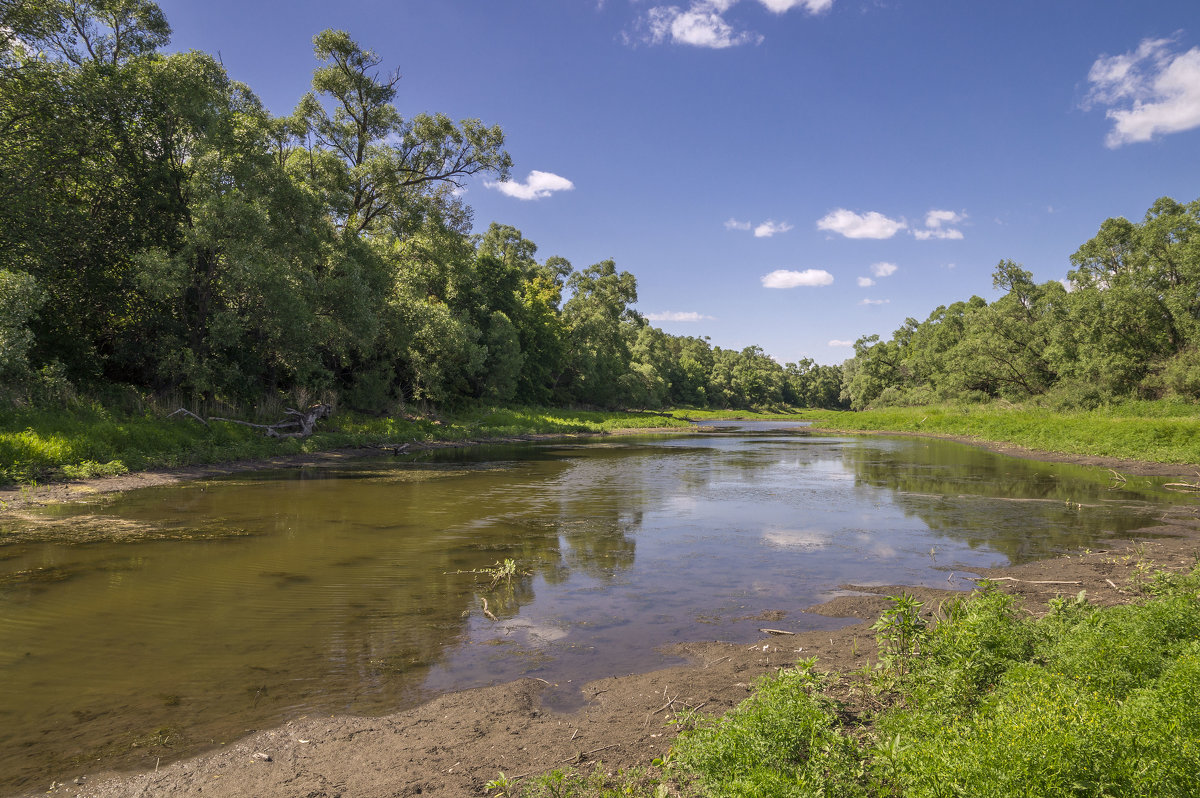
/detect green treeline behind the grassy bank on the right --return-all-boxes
[842,197,1200,409]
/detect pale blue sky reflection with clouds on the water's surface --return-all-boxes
[431,436,1171,705]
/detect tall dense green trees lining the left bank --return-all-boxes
[0,0,841,409]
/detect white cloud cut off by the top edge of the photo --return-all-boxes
[624,0,834,49]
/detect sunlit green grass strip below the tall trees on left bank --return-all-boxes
[0,404,688,484]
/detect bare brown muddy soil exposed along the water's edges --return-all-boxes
[9,432,1200,798]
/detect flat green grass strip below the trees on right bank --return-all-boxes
[806,402,1200,463]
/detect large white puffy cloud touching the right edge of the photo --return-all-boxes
[1084,38,1200,148]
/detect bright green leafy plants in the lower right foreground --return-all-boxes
[491,566,1200,798]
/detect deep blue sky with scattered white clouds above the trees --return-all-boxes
[160,0,1200,364]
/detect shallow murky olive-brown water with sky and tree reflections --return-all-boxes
[0,424,1175,792]
